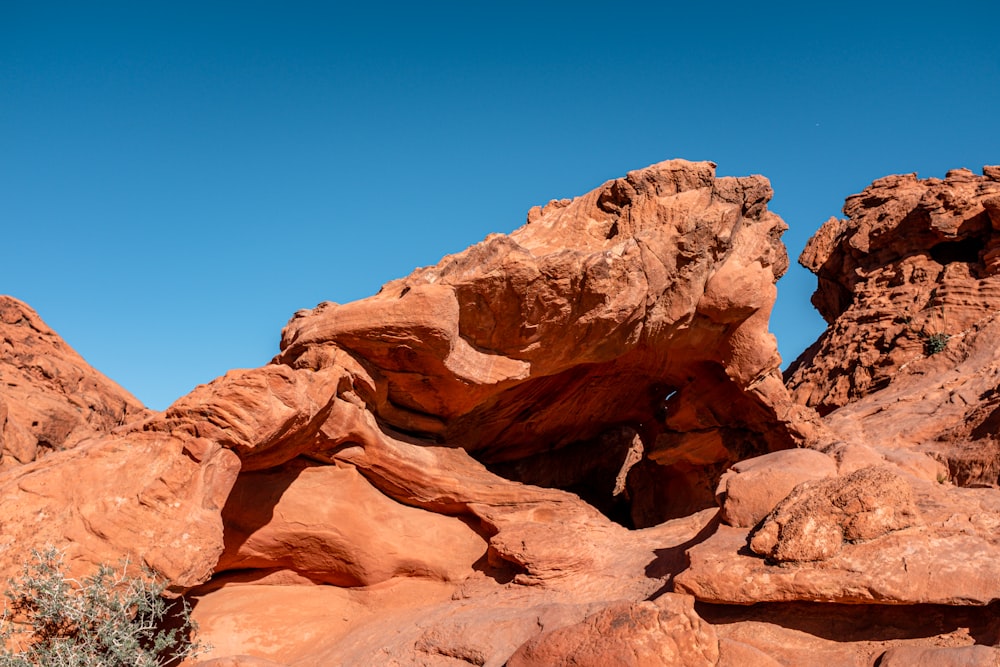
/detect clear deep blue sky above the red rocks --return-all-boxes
[0,0,1000,409]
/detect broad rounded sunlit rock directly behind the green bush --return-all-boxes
[0,433,239,592]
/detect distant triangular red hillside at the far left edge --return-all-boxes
[0,295,149,468]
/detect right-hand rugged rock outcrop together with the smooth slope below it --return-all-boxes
[787,167,1000,485]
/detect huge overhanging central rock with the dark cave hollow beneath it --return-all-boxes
[277,160,802,525]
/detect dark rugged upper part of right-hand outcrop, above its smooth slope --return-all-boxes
[787,167,1000,414]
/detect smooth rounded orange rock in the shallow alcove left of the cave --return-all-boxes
[216,459,486,586]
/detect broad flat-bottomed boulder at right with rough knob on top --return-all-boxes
[673,461,1000,605]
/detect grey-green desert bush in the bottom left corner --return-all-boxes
[0,548,199,667]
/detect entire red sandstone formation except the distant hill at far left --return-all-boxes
[0,160,1000,667]
